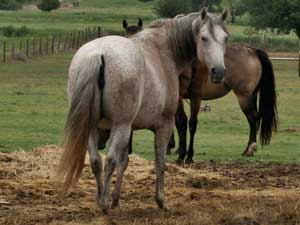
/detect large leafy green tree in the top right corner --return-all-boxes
[243,0,300,38]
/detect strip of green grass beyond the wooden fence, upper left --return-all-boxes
[0,0,155,34]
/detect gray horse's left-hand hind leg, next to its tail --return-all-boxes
[88,129,102,202]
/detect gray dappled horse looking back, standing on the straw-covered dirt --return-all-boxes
[58,9,228,212]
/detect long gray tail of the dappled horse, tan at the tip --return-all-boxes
[57,54,105,191]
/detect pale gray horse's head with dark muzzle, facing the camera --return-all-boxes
[192,8,229,83]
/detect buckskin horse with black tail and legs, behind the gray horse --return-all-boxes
[175,43,278,163]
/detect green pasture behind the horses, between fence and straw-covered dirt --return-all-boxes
[0,53,300,163]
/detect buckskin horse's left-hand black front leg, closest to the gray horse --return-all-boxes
[175,98,187,164]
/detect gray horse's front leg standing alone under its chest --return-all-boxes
[155,118,174,208]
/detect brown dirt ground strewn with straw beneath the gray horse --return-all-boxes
[0,146,300,225]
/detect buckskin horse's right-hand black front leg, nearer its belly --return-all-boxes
[185,98,201,163]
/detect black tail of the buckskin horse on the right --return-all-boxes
[256,49,278,145]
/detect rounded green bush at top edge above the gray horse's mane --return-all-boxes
[154,0,191,18]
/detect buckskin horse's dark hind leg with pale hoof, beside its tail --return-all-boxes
[238,95,259,156]
